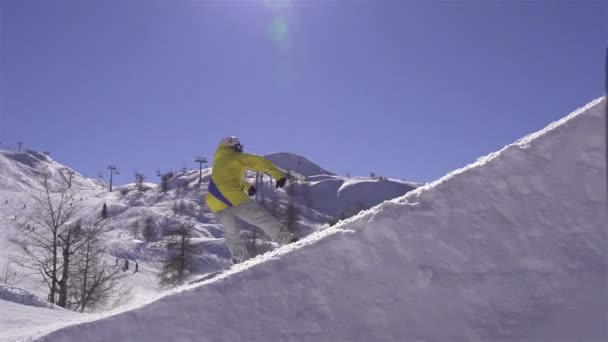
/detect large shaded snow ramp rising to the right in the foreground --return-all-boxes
[30,99,608,342]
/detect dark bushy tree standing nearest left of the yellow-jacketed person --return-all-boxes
[158,224,197,288]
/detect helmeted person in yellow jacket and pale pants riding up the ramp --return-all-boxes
[205,137,297,264]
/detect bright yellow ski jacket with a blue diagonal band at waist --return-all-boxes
[205,146,285,213]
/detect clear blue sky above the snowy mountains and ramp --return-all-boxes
[0,0,608,183]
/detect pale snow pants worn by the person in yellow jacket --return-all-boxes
[215,201,294,262]
